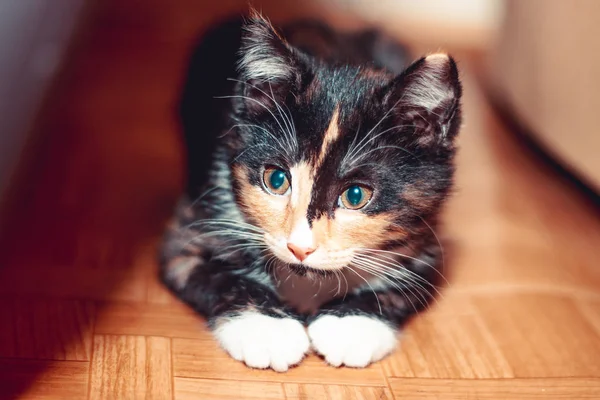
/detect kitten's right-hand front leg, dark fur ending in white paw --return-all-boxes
[308,245,435,367]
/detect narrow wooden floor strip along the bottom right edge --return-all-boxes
[389,378,600,400]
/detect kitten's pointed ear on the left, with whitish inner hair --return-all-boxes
[238,10,296,83]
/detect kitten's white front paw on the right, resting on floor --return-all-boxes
[308,315,396,368]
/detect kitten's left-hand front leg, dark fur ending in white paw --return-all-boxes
[161,222,310,371]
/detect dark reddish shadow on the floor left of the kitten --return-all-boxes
[0,0,368,398]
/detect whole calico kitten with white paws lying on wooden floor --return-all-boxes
[161,13,461,371]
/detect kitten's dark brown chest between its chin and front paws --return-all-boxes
[274,265,368,314]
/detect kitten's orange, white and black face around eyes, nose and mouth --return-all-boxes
[234,106,405,270]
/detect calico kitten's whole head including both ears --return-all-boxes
[230,15,461,270]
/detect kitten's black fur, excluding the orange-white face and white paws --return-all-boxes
[161,15,462,334]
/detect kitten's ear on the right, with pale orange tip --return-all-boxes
[387,54,462,148]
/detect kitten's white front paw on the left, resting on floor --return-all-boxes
[214,312,310,372]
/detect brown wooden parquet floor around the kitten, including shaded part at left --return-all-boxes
[0,0,600,400]
